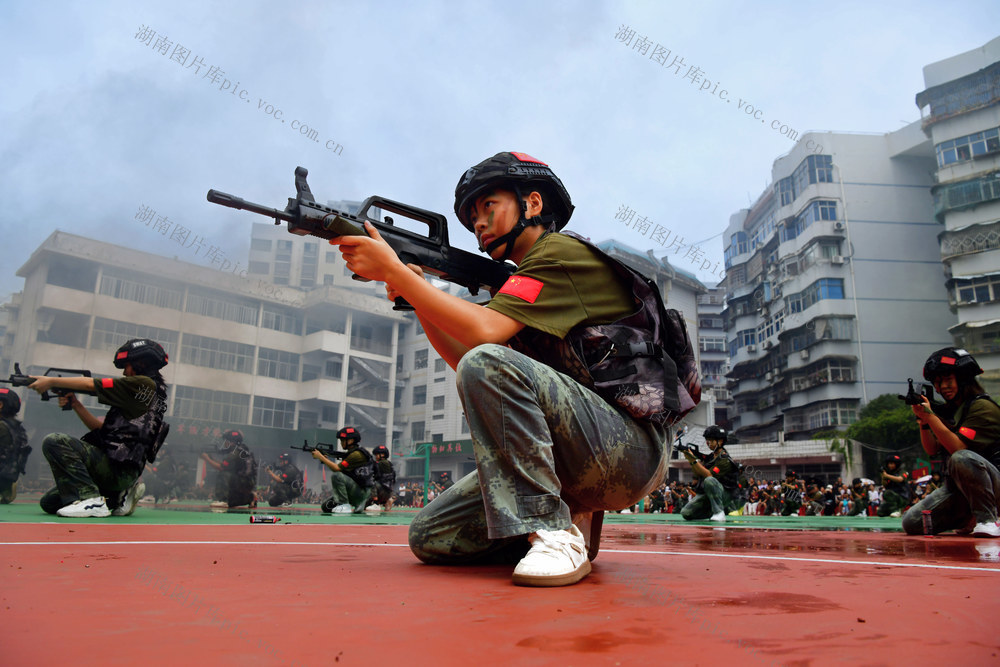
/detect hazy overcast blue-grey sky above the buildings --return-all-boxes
[0,0,1000,298]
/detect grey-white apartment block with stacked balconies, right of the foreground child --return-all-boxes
[723,123,954,441]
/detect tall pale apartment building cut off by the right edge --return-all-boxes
[916,37,1000,395]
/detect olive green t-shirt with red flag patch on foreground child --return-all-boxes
[486,233,636,338]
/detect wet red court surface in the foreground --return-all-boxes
[0,523,1000,667]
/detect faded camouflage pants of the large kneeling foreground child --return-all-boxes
[409,345,668,563]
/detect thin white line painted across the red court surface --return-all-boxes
[0,540,1000,574]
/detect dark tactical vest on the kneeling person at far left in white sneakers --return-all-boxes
[83,376,167,470]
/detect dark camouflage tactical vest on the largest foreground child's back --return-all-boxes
[511,232,701,426]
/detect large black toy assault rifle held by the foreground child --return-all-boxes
[208,167,514,310]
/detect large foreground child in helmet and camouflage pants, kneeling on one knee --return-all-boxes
[331,153,684,586]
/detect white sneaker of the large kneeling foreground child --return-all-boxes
[514,526,590,586]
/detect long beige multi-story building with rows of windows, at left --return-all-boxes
[6,232,407,488]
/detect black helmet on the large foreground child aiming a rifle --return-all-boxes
[455,152,574,232]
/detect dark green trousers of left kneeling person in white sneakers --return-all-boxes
[38,433,140,514]
